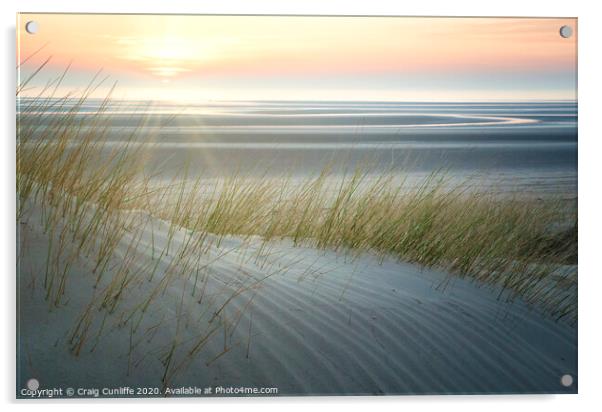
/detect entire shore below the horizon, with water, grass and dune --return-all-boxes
[17,99,577,397]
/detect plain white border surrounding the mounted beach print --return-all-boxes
[0,0,602,412]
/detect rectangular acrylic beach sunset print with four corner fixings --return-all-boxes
[16,13,578,398]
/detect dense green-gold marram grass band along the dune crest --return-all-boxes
[17,75,577,326]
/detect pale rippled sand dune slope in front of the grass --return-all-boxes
[18,203,577,395]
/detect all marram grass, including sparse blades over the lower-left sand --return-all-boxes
[17,66,577,386]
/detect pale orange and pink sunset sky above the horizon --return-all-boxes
[17,14,577,102]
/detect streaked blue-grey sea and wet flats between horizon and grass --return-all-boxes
[17,98,577,197]
